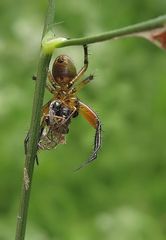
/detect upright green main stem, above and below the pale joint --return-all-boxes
[15,0,55,240]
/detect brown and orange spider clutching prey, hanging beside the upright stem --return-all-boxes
[25,45,101,170]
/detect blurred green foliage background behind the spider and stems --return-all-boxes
[0,0,166,240]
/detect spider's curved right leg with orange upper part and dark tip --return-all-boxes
[76,102,101,171]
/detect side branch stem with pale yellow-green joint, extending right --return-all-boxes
[42,15,166,53]
